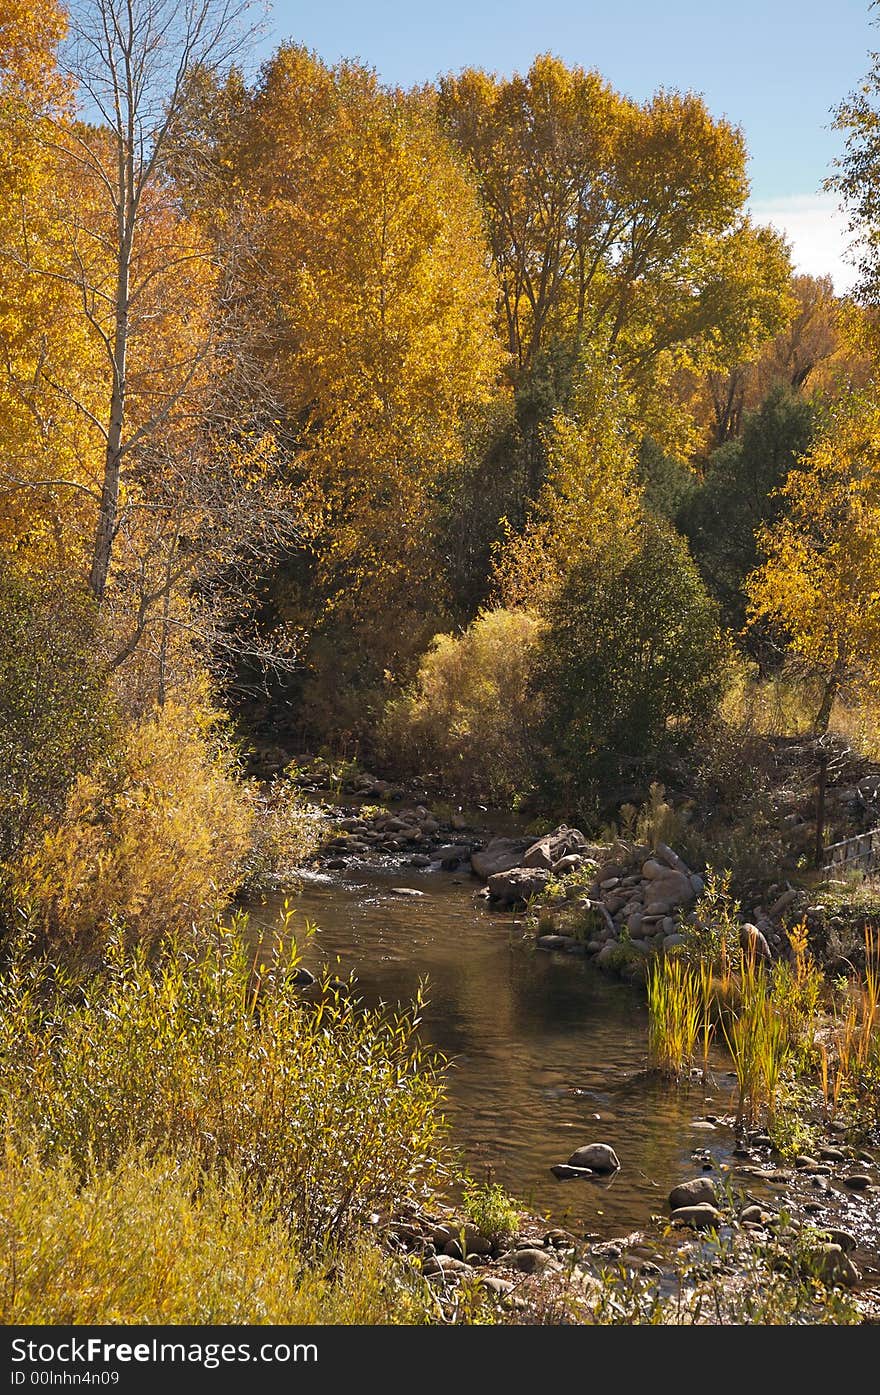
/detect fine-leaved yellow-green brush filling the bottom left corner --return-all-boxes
[0,1149,437,1325]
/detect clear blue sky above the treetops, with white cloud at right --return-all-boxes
[261,0,880,293]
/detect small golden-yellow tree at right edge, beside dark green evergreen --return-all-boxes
[748,392,880,732]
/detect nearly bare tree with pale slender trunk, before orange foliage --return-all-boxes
[3,0,302,700]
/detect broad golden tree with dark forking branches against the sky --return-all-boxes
[438,54,789,446]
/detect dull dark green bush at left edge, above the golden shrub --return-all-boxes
[0,564,113,864]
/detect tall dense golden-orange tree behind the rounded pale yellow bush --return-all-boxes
[223,46,499,736]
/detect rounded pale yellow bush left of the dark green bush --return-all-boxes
[381,610,541,799]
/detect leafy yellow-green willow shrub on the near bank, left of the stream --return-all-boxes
[0,918,445,1251]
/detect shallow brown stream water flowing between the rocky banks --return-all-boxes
[242,866,734,1239]
